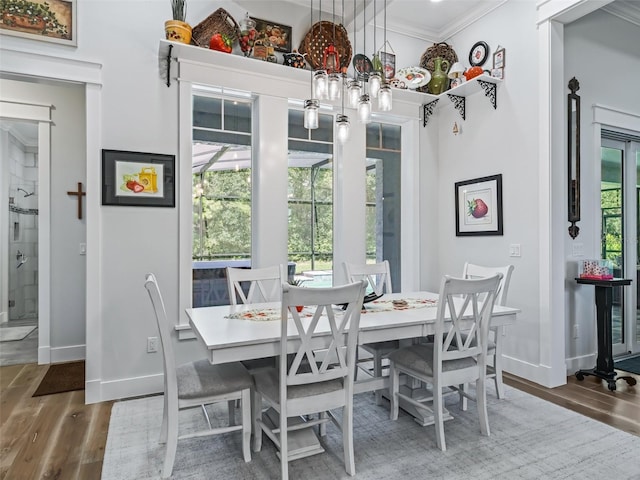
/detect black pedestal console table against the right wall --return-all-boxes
[576,278,636,391]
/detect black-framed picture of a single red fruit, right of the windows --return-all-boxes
[455,174,502,237]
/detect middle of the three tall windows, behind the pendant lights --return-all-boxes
[288,110,333,286]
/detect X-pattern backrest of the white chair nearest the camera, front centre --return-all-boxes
[280,281,366,388]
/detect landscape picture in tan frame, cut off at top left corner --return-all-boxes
[0,0,77,46]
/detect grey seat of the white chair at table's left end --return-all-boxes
[176,360,253,399]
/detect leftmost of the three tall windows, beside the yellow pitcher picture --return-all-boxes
[193,94,251,260]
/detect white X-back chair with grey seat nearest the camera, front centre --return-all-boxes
[253,281,366,480]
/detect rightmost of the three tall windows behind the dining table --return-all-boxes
[366,122,402,291]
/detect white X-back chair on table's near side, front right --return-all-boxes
[388,273,502,450]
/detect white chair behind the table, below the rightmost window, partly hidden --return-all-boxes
[343,260,400,405]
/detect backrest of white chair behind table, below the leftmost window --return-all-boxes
[227,265,287,305]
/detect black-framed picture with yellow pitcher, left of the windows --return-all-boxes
[102,150,176,207]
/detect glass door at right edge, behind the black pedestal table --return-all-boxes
[600,129,640,355]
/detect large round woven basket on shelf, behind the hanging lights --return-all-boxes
[298,20,353,70]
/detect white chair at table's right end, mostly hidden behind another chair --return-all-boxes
[462,262,514,398]
